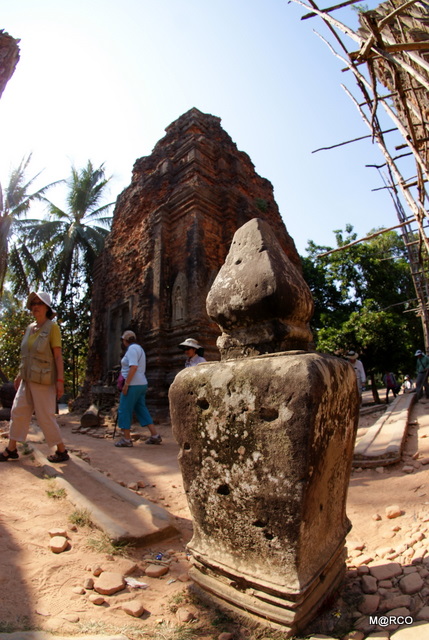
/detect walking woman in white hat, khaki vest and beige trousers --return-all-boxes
[0,291,69,462]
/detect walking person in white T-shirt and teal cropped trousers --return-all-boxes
[115,331,162,447]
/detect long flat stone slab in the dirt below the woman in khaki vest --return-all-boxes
[34,445,178,545]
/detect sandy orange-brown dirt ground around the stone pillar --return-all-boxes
[0,400,429,640]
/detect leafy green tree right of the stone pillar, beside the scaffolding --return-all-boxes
[304,225,422,399]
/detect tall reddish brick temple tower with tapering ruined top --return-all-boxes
[88,108,300,418]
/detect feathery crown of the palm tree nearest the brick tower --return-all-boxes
[31,160,114,301]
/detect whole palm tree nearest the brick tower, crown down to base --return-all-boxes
[21,161,113,396]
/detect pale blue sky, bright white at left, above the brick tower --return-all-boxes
[0,0,404,254]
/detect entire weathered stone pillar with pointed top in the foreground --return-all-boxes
[170,219,359,634]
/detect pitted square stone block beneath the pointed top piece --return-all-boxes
[170,351,359,633]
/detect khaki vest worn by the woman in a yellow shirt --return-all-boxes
[19,320,57,384]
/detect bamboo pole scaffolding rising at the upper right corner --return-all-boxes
[293,0,429,349]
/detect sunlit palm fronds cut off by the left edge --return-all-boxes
[0,153,61,296]
